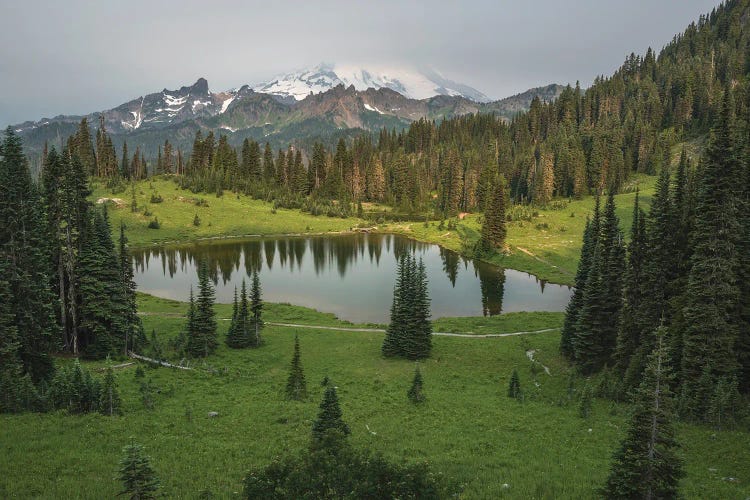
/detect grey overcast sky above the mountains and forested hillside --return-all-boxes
[0,0,718,126]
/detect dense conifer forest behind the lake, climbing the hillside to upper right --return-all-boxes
[60,0,748,223]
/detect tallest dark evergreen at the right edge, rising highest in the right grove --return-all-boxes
[680,92,740,420]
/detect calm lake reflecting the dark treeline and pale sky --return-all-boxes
[132,234,572,323]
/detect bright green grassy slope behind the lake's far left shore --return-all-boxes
[91,177,360,246]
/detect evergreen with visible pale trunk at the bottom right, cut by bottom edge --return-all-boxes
[602,327,683,499]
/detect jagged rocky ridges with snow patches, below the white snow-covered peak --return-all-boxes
[14,75,562,157]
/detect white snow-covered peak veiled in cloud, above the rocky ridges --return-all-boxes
[253,64,491,103]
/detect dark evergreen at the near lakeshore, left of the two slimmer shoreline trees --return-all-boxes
[185,260,218,357]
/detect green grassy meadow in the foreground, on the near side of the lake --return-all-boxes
[0,295,750,499]
